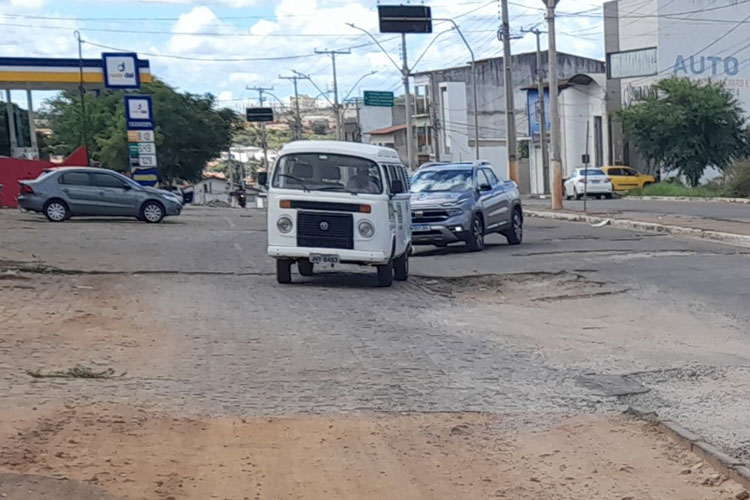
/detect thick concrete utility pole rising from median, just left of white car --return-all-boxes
[544,0,563,210]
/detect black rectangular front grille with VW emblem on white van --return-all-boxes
[297,212,354,250]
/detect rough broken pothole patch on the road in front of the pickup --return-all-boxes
[417,271,629,304]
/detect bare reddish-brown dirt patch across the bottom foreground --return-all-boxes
[0,407,741,500]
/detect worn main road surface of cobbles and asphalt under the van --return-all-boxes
[0,206,750,458]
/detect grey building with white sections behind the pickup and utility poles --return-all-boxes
[414,52,604,188]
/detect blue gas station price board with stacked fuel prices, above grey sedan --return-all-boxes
[125,95,159,186]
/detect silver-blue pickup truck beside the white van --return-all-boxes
[410,161,523,251]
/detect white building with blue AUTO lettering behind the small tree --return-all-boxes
[604,0,750,169]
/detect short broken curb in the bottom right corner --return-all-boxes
[625,406,750,490]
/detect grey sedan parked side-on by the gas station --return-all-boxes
[18,167,182,223]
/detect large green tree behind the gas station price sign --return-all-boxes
[48,80,240,181]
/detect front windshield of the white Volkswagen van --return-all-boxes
[272,153,383,194]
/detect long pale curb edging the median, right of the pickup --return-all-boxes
[525,210,750,247]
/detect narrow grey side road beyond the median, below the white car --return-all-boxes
[524,198,750,224]
